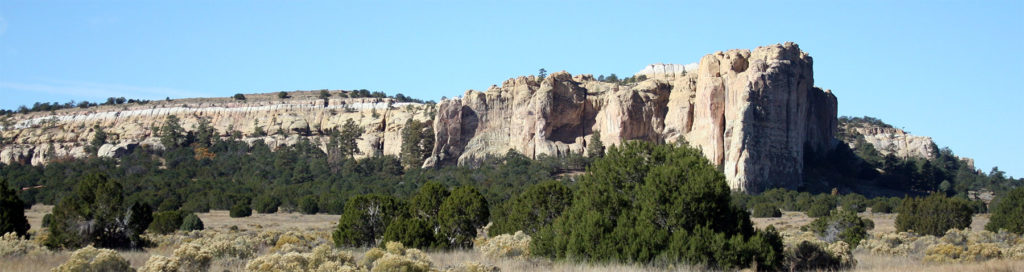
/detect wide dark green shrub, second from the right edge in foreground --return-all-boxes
[896,194,974,236]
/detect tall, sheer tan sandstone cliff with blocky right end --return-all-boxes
[426,43,838,191]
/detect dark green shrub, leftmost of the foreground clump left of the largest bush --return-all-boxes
[331,194,408,246]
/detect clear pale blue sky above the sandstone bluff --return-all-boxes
[0,0,1024,177]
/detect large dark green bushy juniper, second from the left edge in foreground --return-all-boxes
[44,174,152,248]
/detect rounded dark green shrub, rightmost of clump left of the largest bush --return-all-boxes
[437,186,490,248]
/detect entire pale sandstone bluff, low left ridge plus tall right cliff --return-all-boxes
[0,43,838,192]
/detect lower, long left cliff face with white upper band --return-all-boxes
[0,92,433,165]
